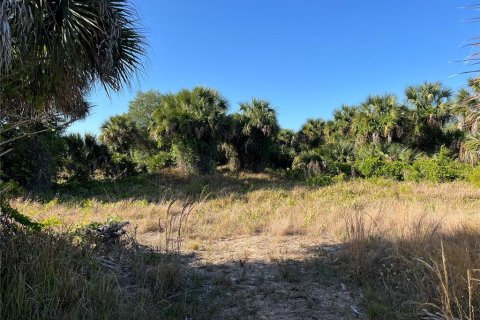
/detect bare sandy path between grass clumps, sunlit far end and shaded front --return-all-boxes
[184,236,364,320]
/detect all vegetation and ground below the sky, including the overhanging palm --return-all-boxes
[0,0,480,320]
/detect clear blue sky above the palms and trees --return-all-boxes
[69,0,480,134]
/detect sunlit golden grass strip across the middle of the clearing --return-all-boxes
[12,175,480,245]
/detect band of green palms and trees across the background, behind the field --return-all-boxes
[1,79,480,189]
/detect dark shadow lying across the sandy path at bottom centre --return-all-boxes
[178,241,365,320]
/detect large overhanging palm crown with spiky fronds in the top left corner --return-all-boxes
[0,0,144,129]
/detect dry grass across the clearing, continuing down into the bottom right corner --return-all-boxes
[12,174,480,319]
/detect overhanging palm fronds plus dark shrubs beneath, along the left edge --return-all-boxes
[0,0,145,199]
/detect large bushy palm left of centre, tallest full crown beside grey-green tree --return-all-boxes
[151,87,228,173]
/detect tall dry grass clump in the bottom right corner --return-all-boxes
[343,212,480,320]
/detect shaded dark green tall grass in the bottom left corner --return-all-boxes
[0,225,210,320]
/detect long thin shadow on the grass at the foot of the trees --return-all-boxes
[30,171,305,203]
